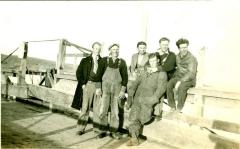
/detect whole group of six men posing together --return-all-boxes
[72,37,197,146]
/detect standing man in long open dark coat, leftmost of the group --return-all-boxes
[72,42,105,138]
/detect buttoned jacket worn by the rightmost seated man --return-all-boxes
[174,51,198,85]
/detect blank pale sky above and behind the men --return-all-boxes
[0,1,240,90]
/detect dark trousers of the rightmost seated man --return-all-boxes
[167,78,194,110]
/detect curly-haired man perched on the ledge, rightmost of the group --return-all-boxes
[167,39,198,112]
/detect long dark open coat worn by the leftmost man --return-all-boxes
[72,55,102,110]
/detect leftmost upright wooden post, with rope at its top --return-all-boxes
[17,42,28,85]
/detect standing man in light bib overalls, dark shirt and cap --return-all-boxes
[100,44,128,139]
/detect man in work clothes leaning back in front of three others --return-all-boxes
[127,53,167,146]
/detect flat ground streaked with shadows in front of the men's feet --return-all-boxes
[1,98,176,149]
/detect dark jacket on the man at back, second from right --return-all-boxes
[156,51,176,80]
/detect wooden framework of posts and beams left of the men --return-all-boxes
[1,39,91,107]
